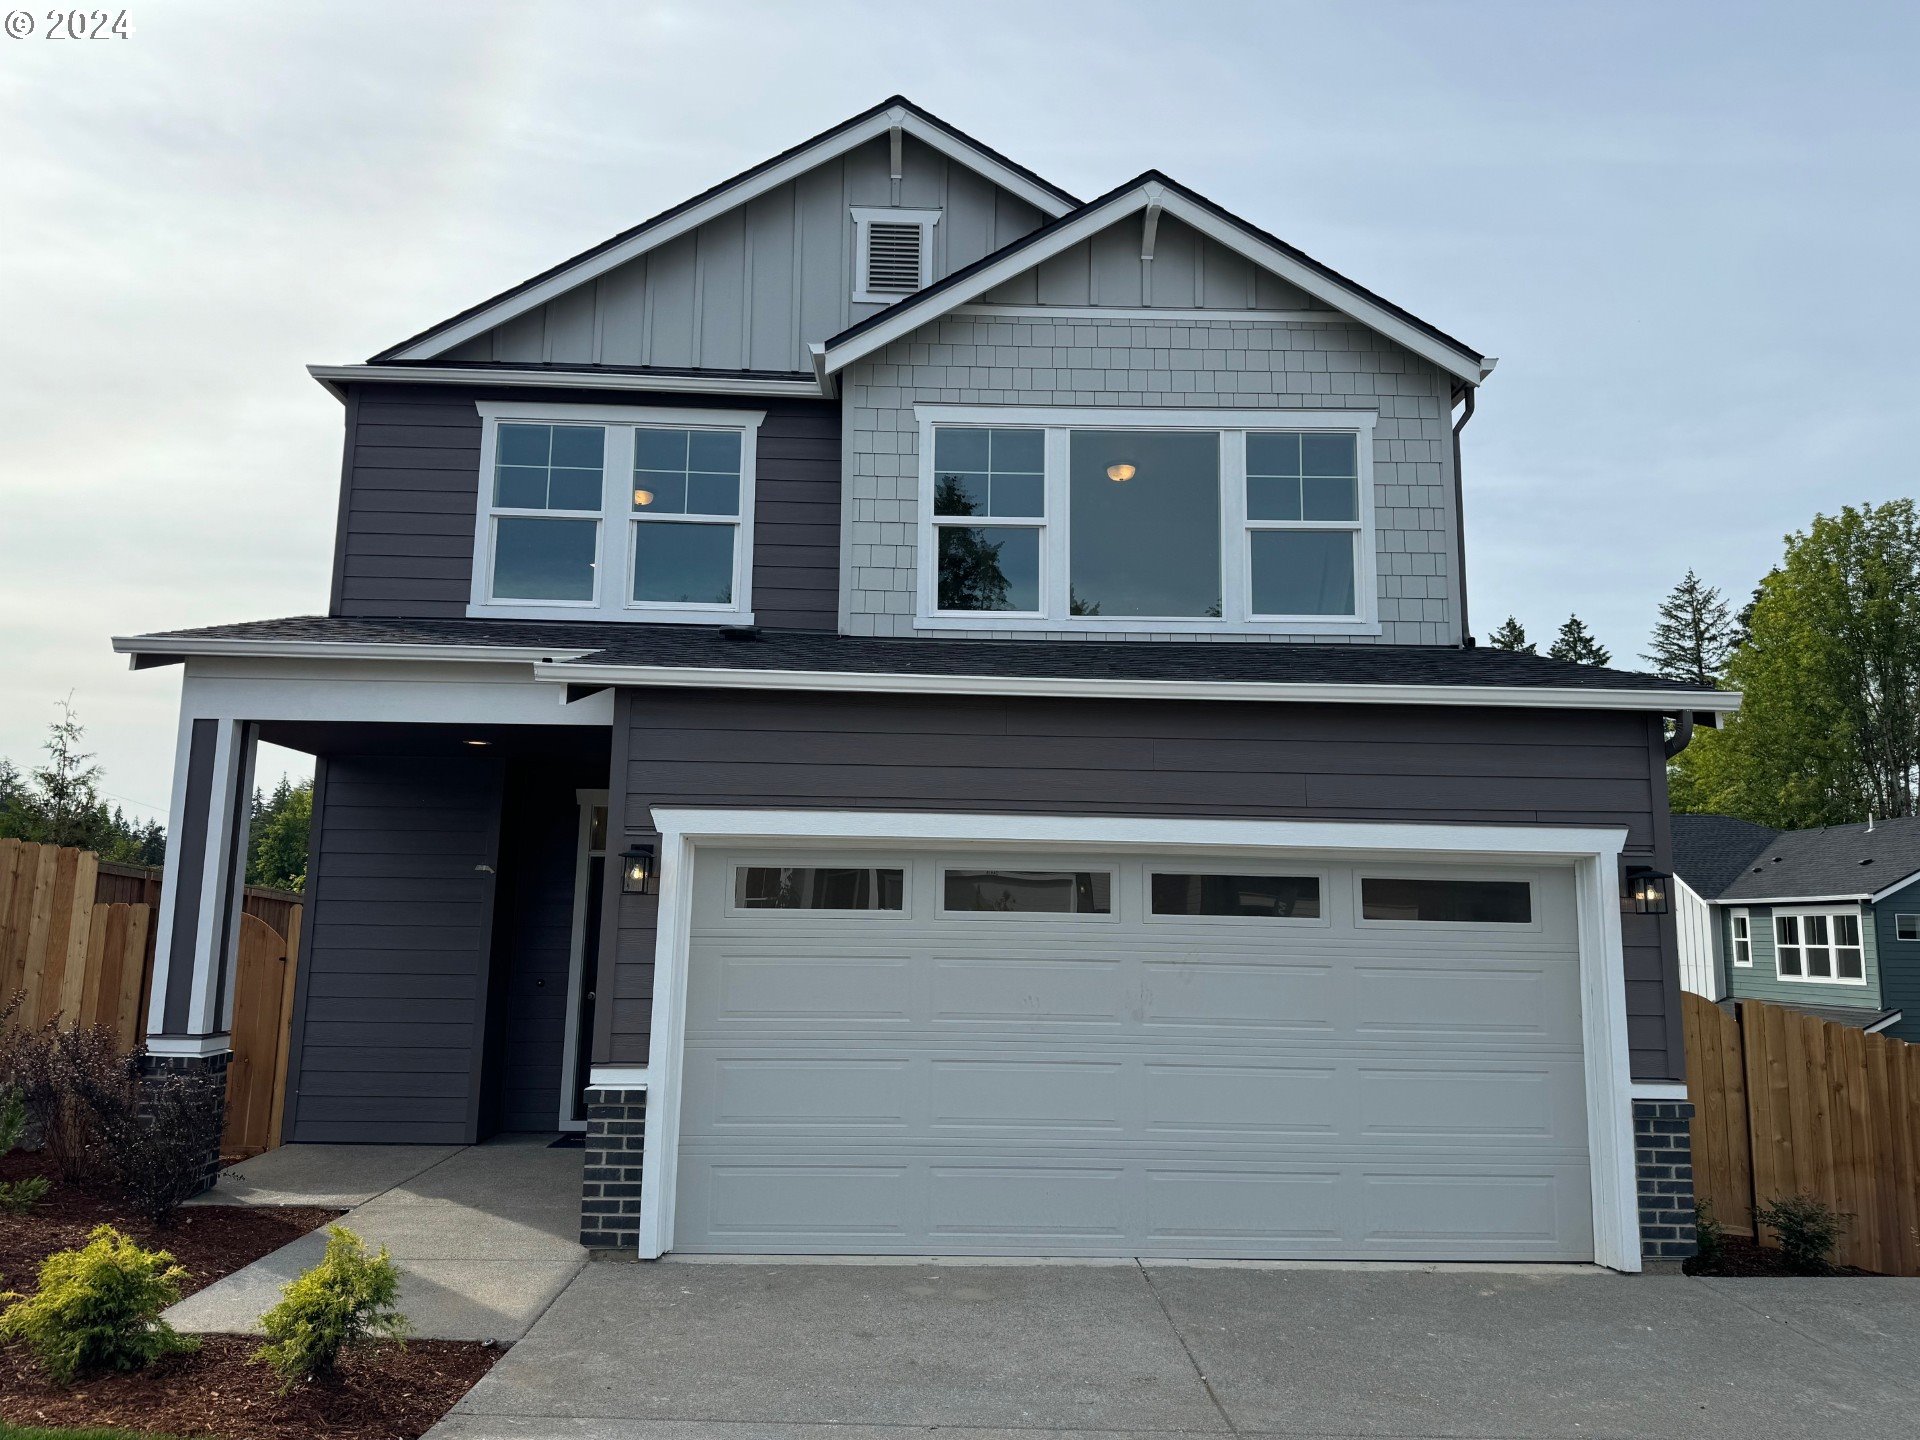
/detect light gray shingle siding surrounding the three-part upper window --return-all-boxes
[841,315,1459,645]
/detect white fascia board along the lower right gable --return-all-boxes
[828,184,1494,384]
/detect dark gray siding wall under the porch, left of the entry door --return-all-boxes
[288,756,501,1144]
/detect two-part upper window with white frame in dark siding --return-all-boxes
[468,403,762,624]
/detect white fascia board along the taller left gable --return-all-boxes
[382,109,1073,359]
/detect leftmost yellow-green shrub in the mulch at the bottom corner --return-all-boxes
[0,1225,200,1384]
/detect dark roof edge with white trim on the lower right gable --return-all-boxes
[820,171,1494,384]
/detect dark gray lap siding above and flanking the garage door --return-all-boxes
[593,689,1684,1081]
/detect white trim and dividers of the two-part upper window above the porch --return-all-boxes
[467,399,766,624]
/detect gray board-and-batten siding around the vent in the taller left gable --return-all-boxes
[447,136,1044,371]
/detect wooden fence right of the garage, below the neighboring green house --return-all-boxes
[1682,995,1920,1275]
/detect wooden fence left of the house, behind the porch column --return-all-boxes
[0,839,301,1156]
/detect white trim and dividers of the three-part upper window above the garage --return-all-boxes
[914,405,1380,636]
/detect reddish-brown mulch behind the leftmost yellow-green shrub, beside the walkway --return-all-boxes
[0,1154,346,1296]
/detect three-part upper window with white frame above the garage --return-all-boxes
[918,405,1379,634]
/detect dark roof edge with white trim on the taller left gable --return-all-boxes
[371,94,1079,363]
